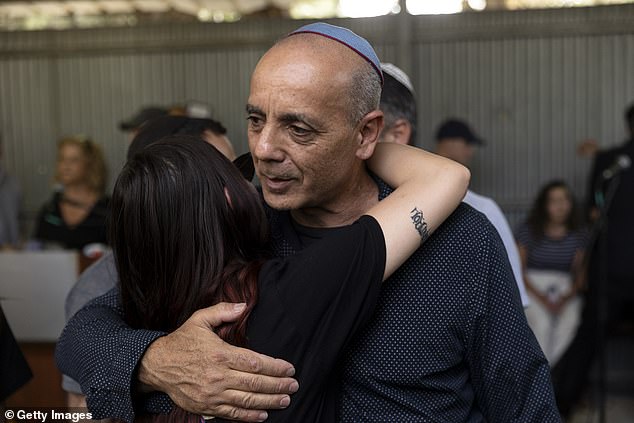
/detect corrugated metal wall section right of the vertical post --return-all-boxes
[415,34,634,227]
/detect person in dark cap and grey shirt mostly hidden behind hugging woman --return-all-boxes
[62,114,242,407]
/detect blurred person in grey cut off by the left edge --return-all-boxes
[0,137,22,250]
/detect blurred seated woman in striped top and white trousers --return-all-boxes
[517,181,587,367]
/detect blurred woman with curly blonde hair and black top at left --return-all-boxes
[33,136,109,251]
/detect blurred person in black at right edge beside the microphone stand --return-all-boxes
[552,103,634,416]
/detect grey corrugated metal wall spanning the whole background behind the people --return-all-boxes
[0,5,634,238]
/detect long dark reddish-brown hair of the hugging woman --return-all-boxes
[110,135,268,422]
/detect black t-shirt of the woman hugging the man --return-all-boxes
[239,216,385,422]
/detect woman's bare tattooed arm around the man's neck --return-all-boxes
[366,143,470,279]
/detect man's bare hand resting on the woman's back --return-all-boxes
[138,303,299,422]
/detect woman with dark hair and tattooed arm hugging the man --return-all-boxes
[110,136,469,422]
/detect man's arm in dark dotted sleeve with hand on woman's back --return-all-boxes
[56,289,297,421]
